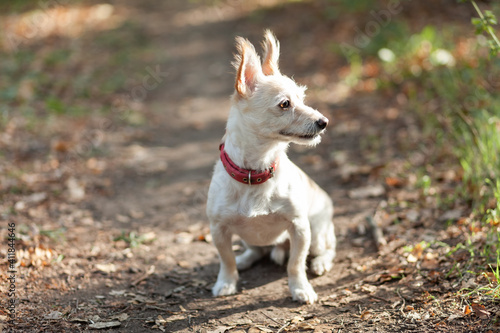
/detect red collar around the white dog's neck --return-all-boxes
[219,143,278,185]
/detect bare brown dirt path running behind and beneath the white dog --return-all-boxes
[5,1,494,332]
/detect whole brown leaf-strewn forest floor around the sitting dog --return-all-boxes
[0,1,500,333]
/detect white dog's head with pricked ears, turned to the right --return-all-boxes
[233,30,328,145]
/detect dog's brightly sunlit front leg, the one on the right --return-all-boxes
[288,218,318,304]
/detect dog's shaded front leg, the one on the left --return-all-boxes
[210,226,238,296]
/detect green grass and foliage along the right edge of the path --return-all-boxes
[333,0,500,298]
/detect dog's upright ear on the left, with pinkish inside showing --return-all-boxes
[233,37,262,98]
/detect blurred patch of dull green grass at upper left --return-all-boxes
[0,11,165,130]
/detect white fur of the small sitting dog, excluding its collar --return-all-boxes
[207,31,336,303]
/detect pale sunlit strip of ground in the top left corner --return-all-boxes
[0,4,123,51]
